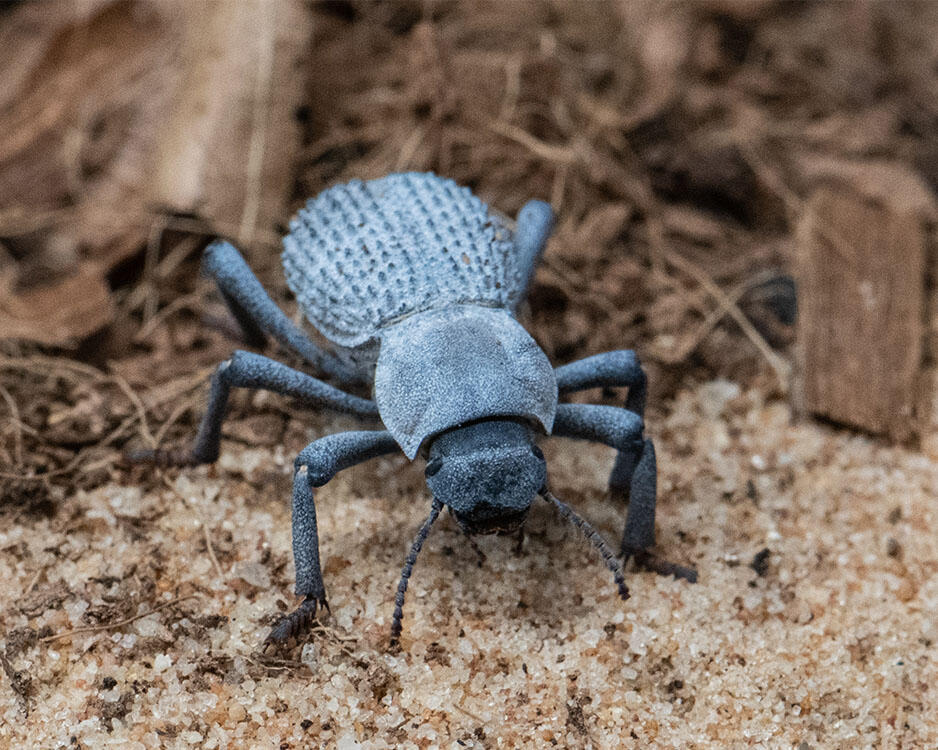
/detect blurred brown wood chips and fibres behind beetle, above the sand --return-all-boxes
[0,0,938,512]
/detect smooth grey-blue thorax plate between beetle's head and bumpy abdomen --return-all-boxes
[375,305,557,459]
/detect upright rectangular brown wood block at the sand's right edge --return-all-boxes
[797,173,930,441]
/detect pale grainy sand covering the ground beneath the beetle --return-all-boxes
[0,382,938,750]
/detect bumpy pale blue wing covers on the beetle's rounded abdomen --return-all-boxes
[283,173,524,346]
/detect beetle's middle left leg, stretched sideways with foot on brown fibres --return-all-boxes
[127,351,378,466]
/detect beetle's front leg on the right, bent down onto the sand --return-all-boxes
[553,404,697,583]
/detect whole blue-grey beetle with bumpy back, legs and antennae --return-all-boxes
[130,173,696,643]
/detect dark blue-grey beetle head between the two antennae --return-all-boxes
[426,420,547,534]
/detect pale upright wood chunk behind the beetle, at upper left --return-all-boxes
[150,0,310,243]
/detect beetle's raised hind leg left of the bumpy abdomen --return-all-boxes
[202,240,363,383]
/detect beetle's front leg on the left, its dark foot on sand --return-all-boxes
[264,430,398,646]
